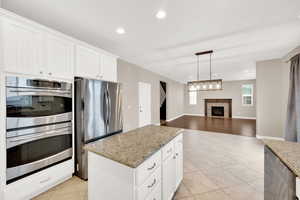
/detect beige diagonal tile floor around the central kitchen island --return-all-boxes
[34,130,264,200]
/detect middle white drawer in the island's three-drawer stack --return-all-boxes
[136,167,161,200]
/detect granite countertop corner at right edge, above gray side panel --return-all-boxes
[263,140,300,177]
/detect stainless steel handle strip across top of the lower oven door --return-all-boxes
[6,128,72,149]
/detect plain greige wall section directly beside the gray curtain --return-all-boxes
[256,59,289,137]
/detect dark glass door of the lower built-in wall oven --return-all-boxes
[6,134,72,181]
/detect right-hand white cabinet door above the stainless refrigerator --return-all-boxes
[101,55,117,82]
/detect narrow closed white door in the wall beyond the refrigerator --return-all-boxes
[139,82,151,127]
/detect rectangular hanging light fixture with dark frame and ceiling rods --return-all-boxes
[187,50,223,92]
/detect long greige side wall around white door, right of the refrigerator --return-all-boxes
[118,59,184,130]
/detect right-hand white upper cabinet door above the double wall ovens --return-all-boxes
[45,35,74,79]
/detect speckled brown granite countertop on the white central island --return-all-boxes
[84,125,182,168]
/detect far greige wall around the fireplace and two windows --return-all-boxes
[185,80,256,118]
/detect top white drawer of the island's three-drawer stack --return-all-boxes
[136,151,161,186]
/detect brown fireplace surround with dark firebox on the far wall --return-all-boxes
[205,99,232,118]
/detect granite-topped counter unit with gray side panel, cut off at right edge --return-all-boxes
[263,140,300,200]
